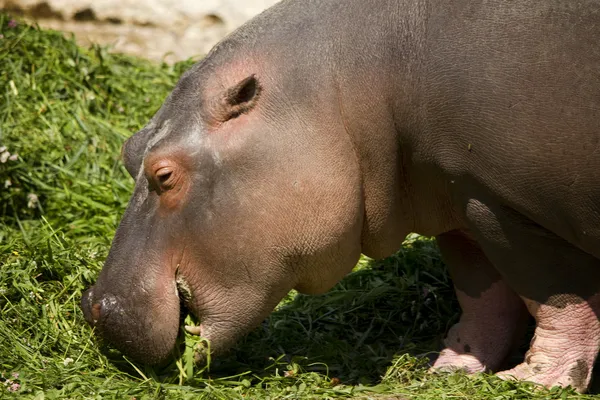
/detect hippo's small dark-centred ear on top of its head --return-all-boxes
[212,75,262,122]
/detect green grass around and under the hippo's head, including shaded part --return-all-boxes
[0,15,595,399]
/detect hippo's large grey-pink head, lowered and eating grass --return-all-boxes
[82,51,364,364]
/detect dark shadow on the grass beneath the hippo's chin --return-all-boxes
[211,238,459,384]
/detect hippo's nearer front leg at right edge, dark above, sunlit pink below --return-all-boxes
[467,199,600,392]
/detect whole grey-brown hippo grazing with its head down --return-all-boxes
[82,0,600,391]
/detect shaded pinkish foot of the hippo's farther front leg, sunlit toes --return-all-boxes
[431,280,527,373]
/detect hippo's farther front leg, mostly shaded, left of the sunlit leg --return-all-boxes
[432,231,527,373]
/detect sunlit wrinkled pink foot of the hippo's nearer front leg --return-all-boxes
[497,295,600,392]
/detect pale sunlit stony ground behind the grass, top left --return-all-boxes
[0,0,278,62]
